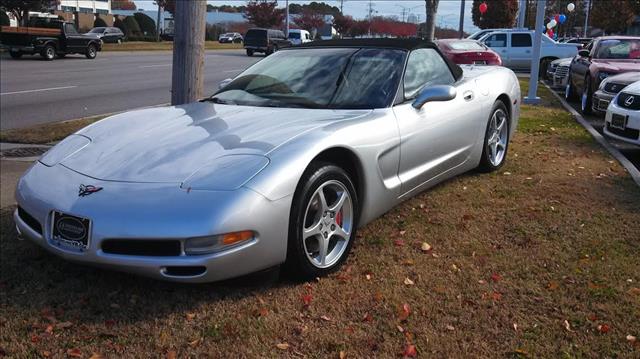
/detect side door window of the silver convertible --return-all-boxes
[404,49,455,100]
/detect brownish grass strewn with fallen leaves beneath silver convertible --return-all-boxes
[0,80,640,358]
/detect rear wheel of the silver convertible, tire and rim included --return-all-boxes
[478,101,509,172]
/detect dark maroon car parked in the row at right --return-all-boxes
[565,36,640,114]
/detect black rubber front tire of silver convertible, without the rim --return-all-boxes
[285,162,360,280]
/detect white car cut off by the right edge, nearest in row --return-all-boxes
[604,81,640,146]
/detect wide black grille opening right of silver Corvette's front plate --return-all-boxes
[102,239,181,257]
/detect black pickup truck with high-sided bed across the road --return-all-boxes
[0,20,102,61]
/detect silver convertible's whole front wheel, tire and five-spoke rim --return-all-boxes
[286,163,359,280]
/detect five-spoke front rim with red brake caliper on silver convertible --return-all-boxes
[302,180,354,268]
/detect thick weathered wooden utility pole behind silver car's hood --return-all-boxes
[171,1,207,106]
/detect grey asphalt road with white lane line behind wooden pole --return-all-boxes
[0,50,262,129]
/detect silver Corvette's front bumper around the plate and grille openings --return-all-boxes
[14,163,291,283]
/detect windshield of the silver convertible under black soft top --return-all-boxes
[210,48,406,109]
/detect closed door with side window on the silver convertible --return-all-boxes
[393,48,480,194]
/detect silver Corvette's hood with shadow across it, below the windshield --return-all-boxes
[60,102,371,183]
